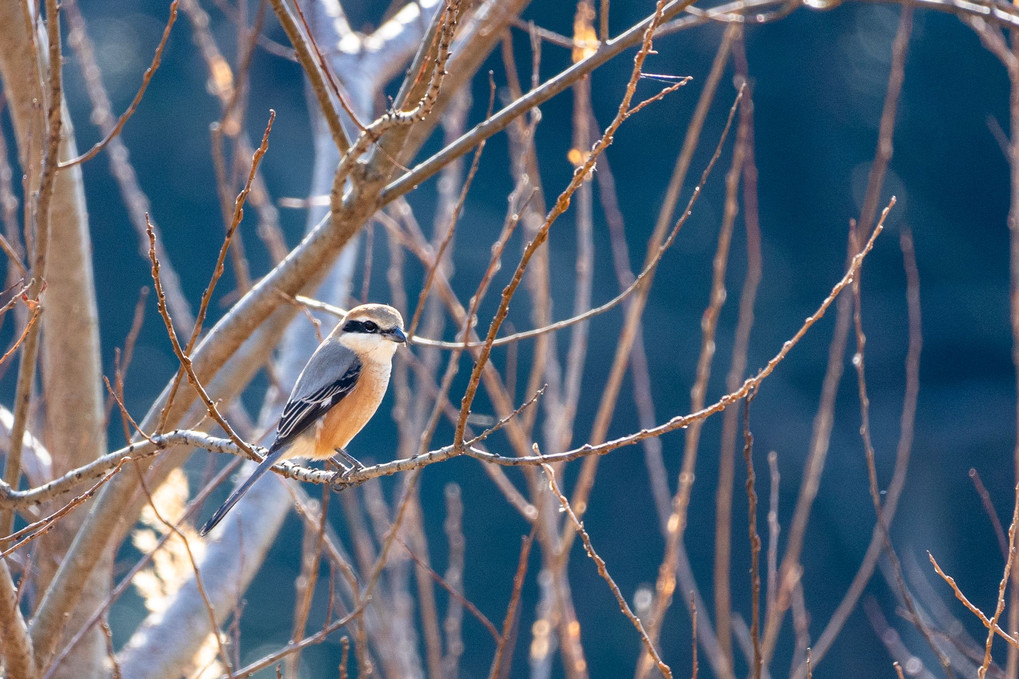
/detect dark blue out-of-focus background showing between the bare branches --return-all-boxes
[0,0,1016,678]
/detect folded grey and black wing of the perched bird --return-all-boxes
[269,342,362,451]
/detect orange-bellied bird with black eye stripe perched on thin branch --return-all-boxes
[199,304,407,536]
